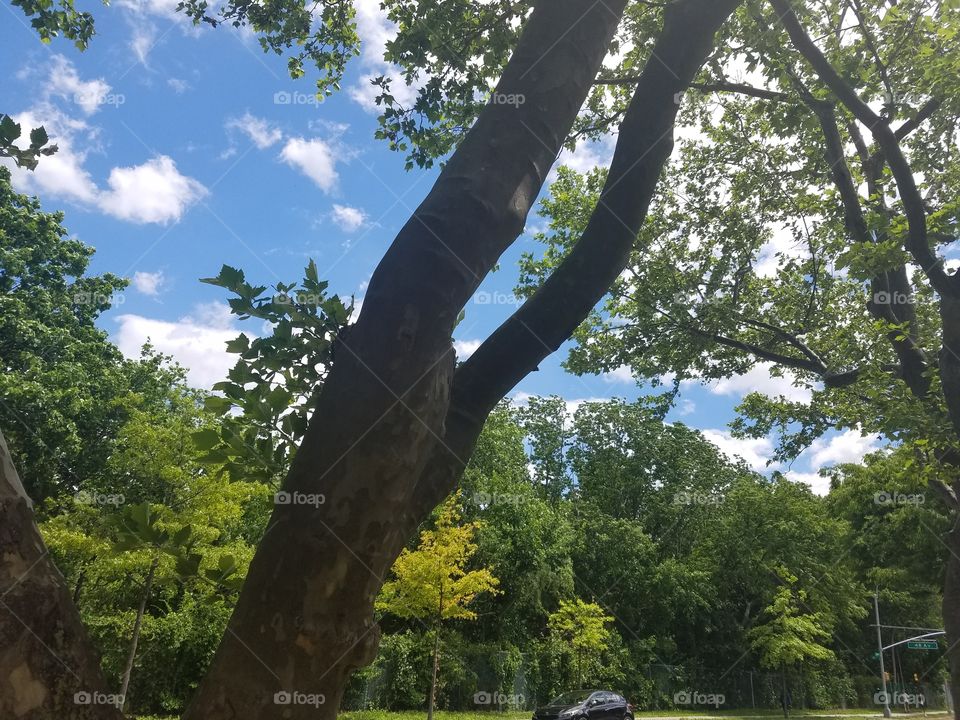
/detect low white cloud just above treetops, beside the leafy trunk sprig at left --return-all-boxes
[114,302,242,388]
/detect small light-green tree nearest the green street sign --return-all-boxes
[747,575,834,717]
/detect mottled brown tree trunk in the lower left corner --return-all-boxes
[0,434,120,720]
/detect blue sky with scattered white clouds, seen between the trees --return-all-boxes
[0,0,878,489]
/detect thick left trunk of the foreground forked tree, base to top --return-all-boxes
[185,0,626,720]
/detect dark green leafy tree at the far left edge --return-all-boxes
[0,168,133,502]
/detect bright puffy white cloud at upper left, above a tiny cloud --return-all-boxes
[98,155,208,223]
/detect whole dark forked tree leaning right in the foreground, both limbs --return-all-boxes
[3,0,739,720]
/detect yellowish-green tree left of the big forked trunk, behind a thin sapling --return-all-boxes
[40,369,262,712]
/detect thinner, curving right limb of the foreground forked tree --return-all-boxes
[404,0,741,515]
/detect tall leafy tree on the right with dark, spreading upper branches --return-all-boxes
[522,0,960,707]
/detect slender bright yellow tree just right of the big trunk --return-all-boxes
[376,493,499,720]
